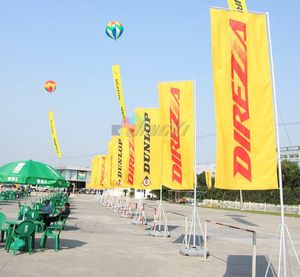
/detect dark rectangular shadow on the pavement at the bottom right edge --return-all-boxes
[223,255,277,277]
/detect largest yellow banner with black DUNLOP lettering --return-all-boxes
[134,108,162,189]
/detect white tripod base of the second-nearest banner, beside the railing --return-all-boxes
[179,202,208,259]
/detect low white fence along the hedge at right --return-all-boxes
[200,199,300,215]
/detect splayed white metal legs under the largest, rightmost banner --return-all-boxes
[265,224,300,277]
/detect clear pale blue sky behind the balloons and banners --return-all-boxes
[0,0,300,166]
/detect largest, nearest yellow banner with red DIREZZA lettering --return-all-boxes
[211,9,278,190]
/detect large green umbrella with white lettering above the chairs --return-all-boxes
[0,160,69,188]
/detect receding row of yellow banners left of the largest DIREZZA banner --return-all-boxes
[89,81,195,190]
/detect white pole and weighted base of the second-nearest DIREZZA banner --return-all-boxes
[179,80,208,259]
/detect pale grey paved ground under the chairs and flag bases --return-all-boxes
[0,195,300,277]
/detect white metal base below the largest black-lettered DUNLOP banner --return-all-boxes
[151,200,170,238]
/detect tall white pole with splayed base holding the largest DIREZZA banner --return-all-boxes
[265,12,300,277]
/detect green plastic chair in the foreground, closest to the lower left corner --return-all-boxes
[6,221,35,256]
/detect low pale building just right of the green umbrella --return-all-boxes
[56,166,91,189]
